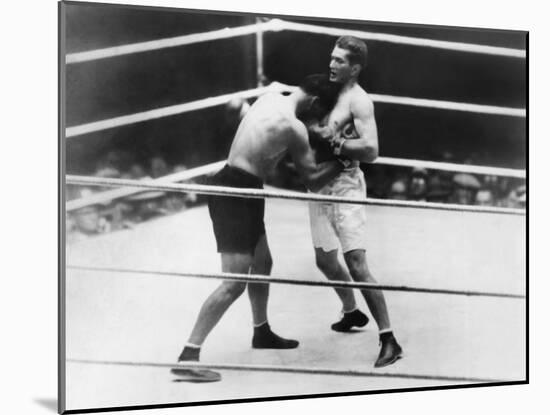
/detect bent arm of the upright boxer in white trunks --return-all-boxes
[340,95,378,163]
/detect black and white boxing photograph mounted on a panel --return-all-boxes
[58,1,529,412]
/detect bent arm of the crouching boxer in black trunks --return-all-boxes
[288,125,343,192]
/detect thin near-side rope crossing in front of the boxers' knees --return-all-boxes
[67,265,525,299]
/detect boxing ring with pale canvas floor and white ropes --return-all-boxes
[62,13,527,409]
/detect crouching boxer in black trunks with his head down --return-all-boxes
[172,75,342,381]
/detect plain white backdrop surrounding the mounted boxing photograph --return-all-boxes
[4,0,550,415]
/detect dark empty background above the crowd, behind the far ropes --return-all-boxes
[62,3,527,174]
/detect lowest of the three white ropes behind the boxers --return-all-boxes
[65,157,525,212]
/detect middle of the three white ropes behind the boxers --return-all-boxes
[65,82,527,138]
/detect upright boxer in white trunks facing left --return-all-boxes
[310,36,402,367]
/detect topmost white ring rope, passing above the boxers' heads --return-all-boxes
[65,19,527,64]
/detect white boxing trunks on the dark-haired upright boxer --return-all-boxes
[309,165,367,253]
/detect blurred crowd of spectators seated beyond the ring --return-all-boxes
[67,151,526,242]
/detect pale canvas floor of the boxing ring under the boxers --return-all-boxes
[66,200,526,410]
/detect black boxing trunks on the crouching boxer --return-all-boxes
[208,165,265,254]
